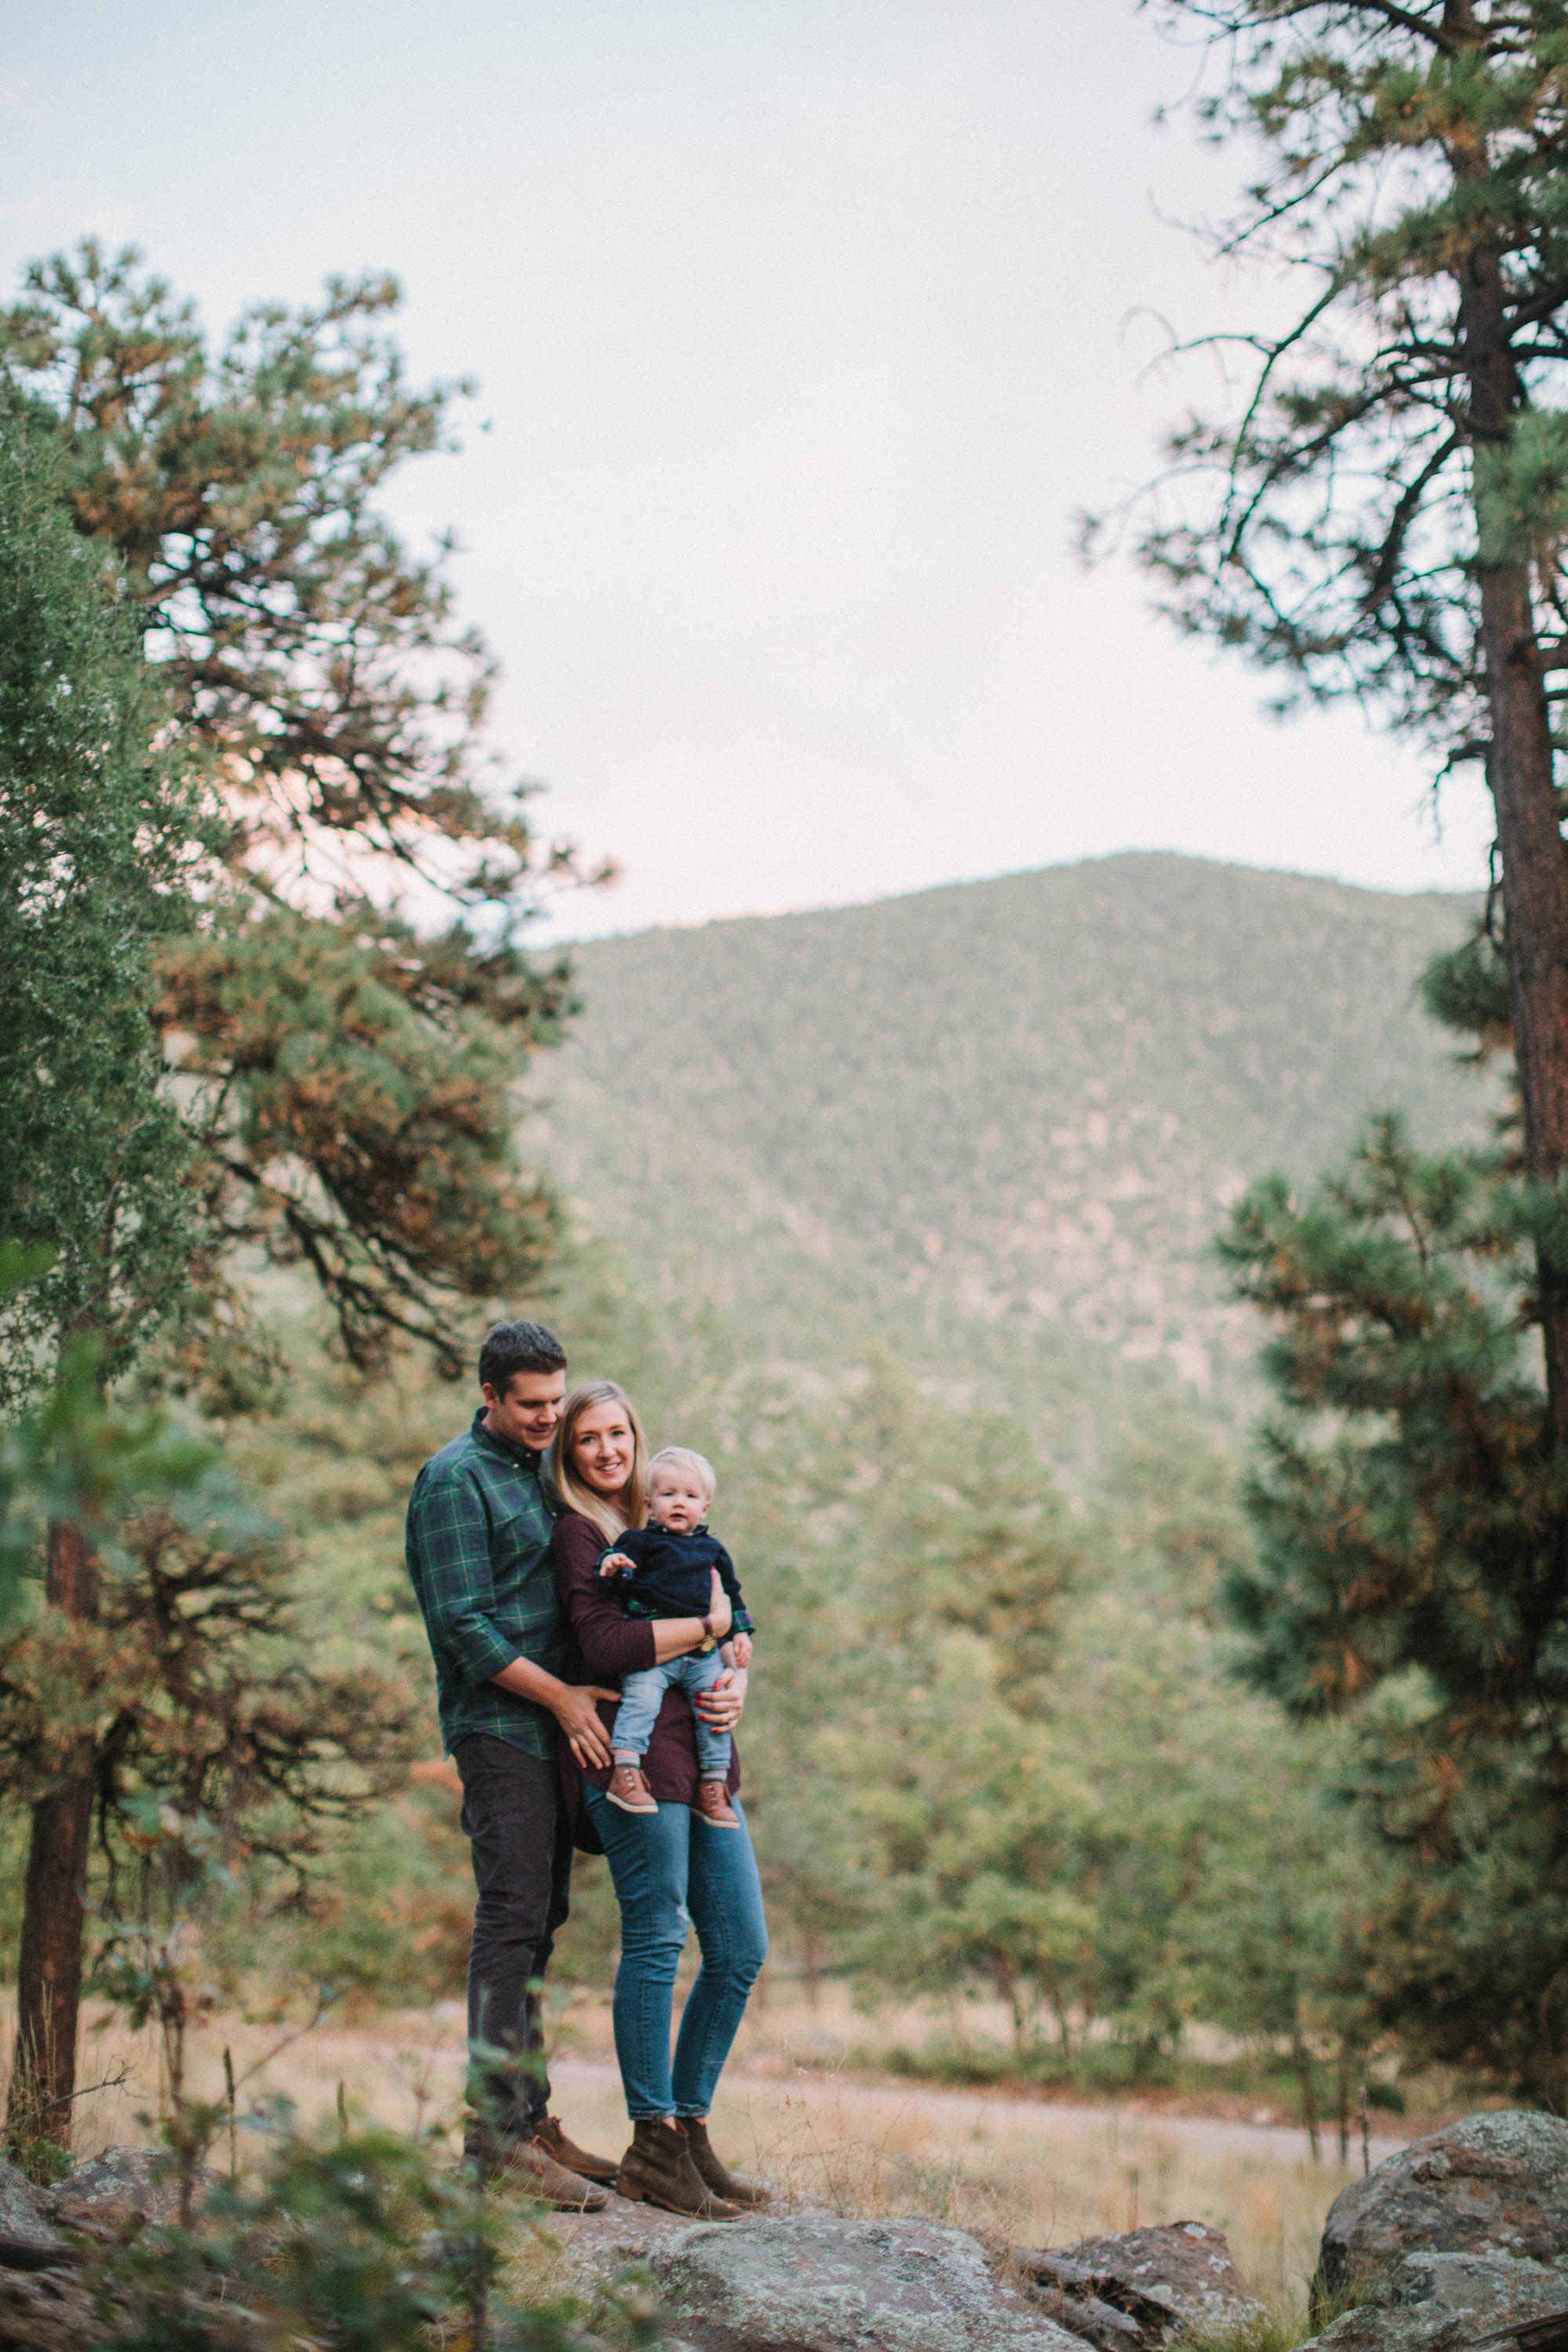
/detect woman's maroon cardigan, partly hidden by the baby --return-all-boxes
[550,1510,741,1853]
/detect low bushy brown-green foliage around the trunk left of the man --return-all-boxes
[0,1355,409,1985]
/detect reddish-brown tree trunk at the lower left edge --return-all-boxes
[5,1522,99,2147]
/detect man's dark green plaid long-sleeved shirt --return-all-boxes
[407,1411,567,1759]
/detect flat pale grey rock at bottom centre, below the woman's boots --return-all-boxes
[652,2216,1081,2352]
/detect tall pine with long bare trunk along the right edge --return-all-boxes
[1140,0,1568,1449]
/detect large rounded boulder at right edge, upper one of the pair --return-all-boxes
[1316,2110,1568,2298]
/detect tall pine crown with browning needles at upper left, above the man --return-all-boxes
[0,242,587,1378]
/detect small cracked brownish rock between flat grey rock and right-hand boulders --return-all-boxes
[1013,2220,1262,2352]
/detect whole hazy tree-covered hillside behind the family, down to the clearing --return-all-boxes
[7,856,1486,2096]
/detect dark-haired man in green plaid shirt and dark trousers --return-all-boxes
[407,1322,616,2213]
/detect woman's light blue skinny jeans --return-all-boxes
[583,1788,769,2124]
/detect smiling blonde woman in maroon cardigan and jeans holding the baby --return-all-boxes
[550,1381,769,2220]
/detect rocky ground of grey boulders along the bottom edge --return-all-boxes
[0,2112,1568,2352]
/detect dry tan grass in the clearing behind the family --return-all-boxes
[7,1999,1394,2328]
